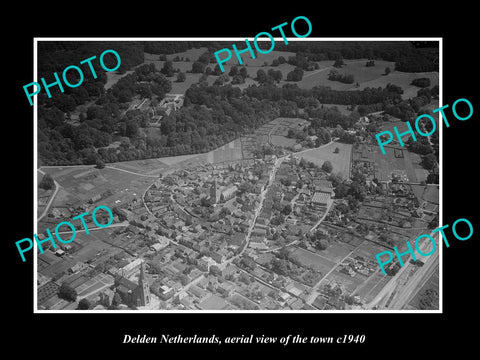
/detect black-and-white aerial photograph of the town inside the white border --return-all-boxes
[35,39,440,312]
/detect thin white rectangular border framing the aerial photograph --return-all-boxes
[33,37,443,314]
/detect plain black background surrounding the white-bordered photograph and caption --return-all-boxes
[2,1,480,358]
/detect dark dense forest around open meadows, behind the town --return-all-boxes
[37,41,438,165]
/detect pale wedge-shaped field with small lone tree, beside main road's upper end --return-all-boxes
[297,142,352,179]
